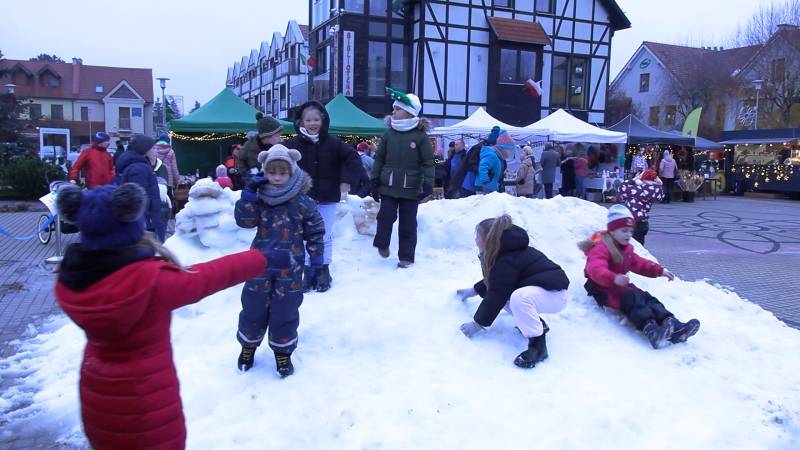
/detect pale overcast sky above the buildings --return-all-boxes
[0,0,771,109]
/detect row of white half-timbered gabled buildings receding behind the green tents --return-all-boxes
[225,20,309,119]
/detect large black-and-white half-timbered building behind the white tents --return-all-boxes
[309,0,630,125]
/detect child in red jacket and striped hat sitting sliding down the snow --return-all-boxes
[579,205,700,349]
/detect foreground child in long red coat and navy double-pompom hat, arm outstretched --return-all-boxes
[55,183,289,450]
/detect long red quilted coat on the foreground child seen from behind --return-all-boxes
[56,250,266,450]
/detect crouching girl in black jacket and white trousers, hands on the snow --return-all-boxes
[457,215,569,369]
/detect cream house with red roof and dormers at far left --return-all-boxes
[0,58,153,146]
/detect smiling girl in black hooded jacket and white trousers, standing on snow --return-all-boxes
[285,101,364,292]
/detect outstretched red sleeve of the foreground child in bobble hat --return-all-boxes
[156,250,267,309]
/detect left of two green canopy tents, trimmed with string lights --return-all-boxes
[170,88,294,177]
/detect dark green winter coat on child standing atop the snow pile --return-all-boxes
[370,119,434,199]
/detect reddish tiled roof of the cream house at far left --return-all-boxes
[0,59,153,103]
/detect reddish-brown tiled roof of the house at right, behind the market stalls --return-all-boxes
[643,41,761,84]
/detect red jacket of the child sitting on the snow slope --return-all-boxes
[583,237,664,309]
